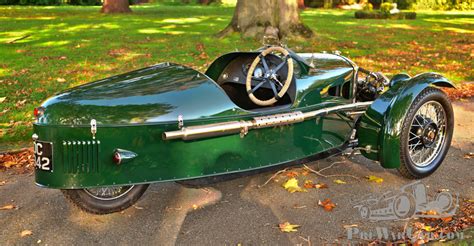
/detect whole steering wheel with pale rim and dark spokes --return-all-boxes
[245,46,293,106]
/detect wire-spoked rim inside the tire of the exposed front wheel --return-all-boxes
[408,101,446,167]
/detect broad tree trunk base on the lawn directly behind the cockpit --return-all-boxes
[219,0,313,40]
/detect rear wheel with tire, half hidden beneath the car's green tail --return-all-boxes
[61,184,148,214]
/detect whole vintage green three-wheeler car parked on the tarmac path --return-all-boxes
[33,46,454,214]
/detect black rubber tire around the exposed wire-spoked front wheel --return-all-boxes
[398,87,454,179]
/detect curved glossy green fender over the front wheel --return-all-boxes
[357,73,455,168]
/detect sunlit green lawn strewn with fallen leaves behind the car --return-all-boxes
[0,5,474,145]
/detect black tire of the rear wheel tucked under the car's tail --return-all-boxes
[61,184,148,214]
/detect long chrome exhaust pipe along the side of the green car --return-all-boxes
[163,102,372,140]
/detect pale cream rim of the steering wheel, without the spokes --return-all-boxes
[245,46,293,106]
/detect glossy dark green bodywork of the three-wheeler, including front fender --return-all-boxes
[34,49,452,189]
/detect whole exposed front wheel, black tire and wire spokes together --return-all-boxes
[398,87,454,179]
